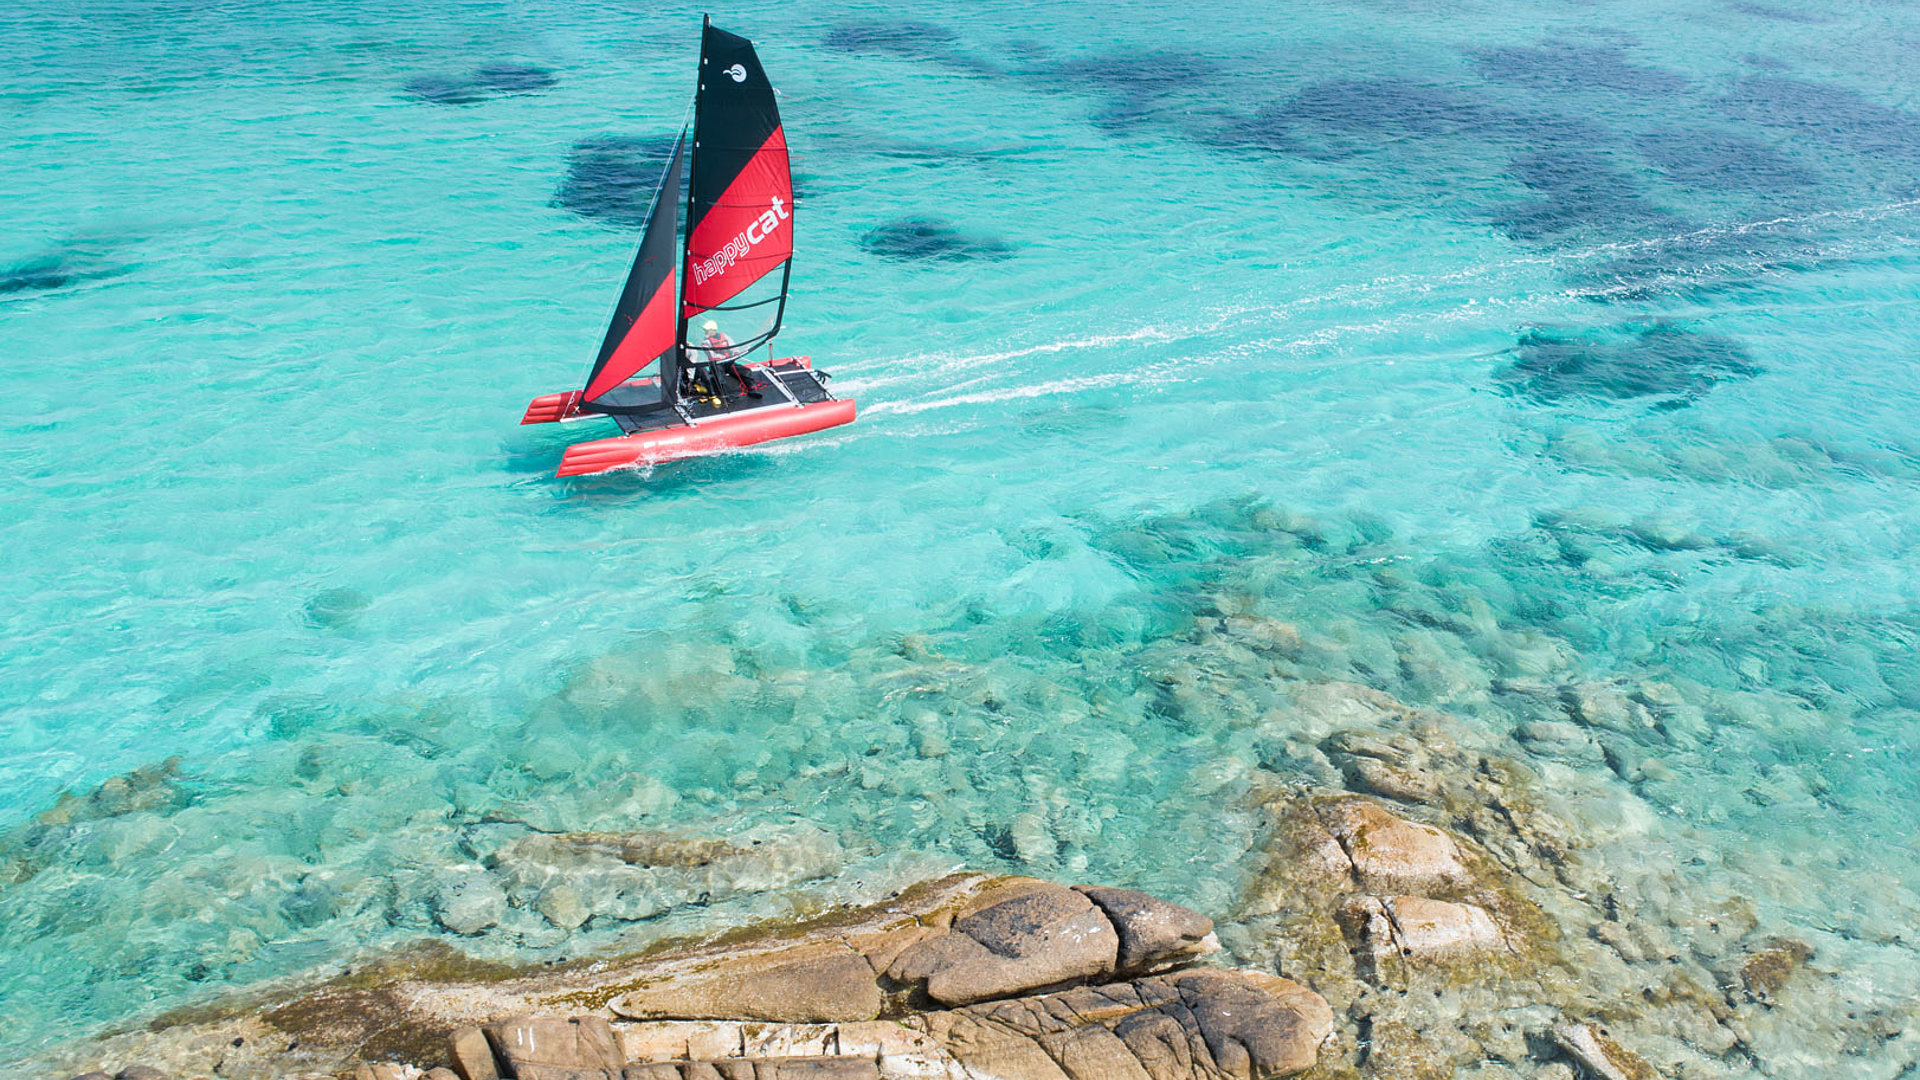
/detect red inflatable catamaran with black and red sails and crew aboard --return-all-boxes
[520,23,854,477]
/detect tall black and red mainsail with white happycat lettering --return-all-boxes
[680,23,793,361]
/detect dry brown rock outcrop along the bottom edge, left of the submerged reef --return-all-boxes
[48,874,1334,1080]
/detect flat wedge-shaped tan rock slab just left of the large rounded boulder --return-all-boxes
[609,942,881,1022]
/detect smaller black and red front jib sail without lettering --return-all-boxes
[580,133,687,415]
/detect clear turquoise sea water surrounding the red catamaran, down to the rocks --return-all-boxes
[0,0,1920,1057]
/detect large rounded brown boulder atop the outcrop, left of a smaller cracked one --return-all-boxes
[898,882,1119,1015]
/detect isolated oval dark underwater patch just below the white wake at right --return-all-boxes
[1498,325,1761,407]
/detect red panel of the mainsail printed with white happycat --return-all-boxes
[685,127,793,317]
